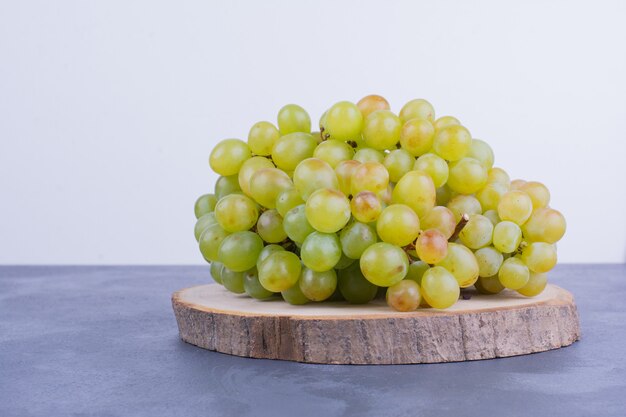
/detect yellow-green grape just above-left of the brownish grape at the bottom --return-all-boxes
[356,242,409,286]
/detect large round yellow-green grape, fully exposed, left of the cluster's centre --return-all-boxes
[305,188,350,233]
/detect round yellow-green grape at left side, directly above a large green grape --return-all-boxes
[215,194,259,233]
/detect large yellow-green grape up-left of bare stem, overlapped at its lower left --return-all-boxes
[391,171,436,217]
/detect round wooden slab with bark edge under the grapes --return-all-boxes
[172,284,580,364]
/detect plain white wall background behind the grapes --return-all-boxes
[0,0,626,264]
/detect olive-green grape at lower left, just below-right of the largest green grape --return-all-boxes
[258,251,302,292]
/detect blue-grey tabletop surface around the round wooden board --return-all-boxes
[0,265,626,417]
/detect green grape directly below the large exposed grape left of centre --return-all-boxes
[300,232,341,272]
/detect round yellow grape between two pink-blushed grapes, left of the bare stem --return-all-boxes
[376,204,420,246]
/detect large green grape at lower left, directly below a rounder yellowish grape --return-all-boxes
[217,231,263,272]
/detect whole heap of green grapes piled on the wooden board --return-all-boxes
[195,95,565,311]
